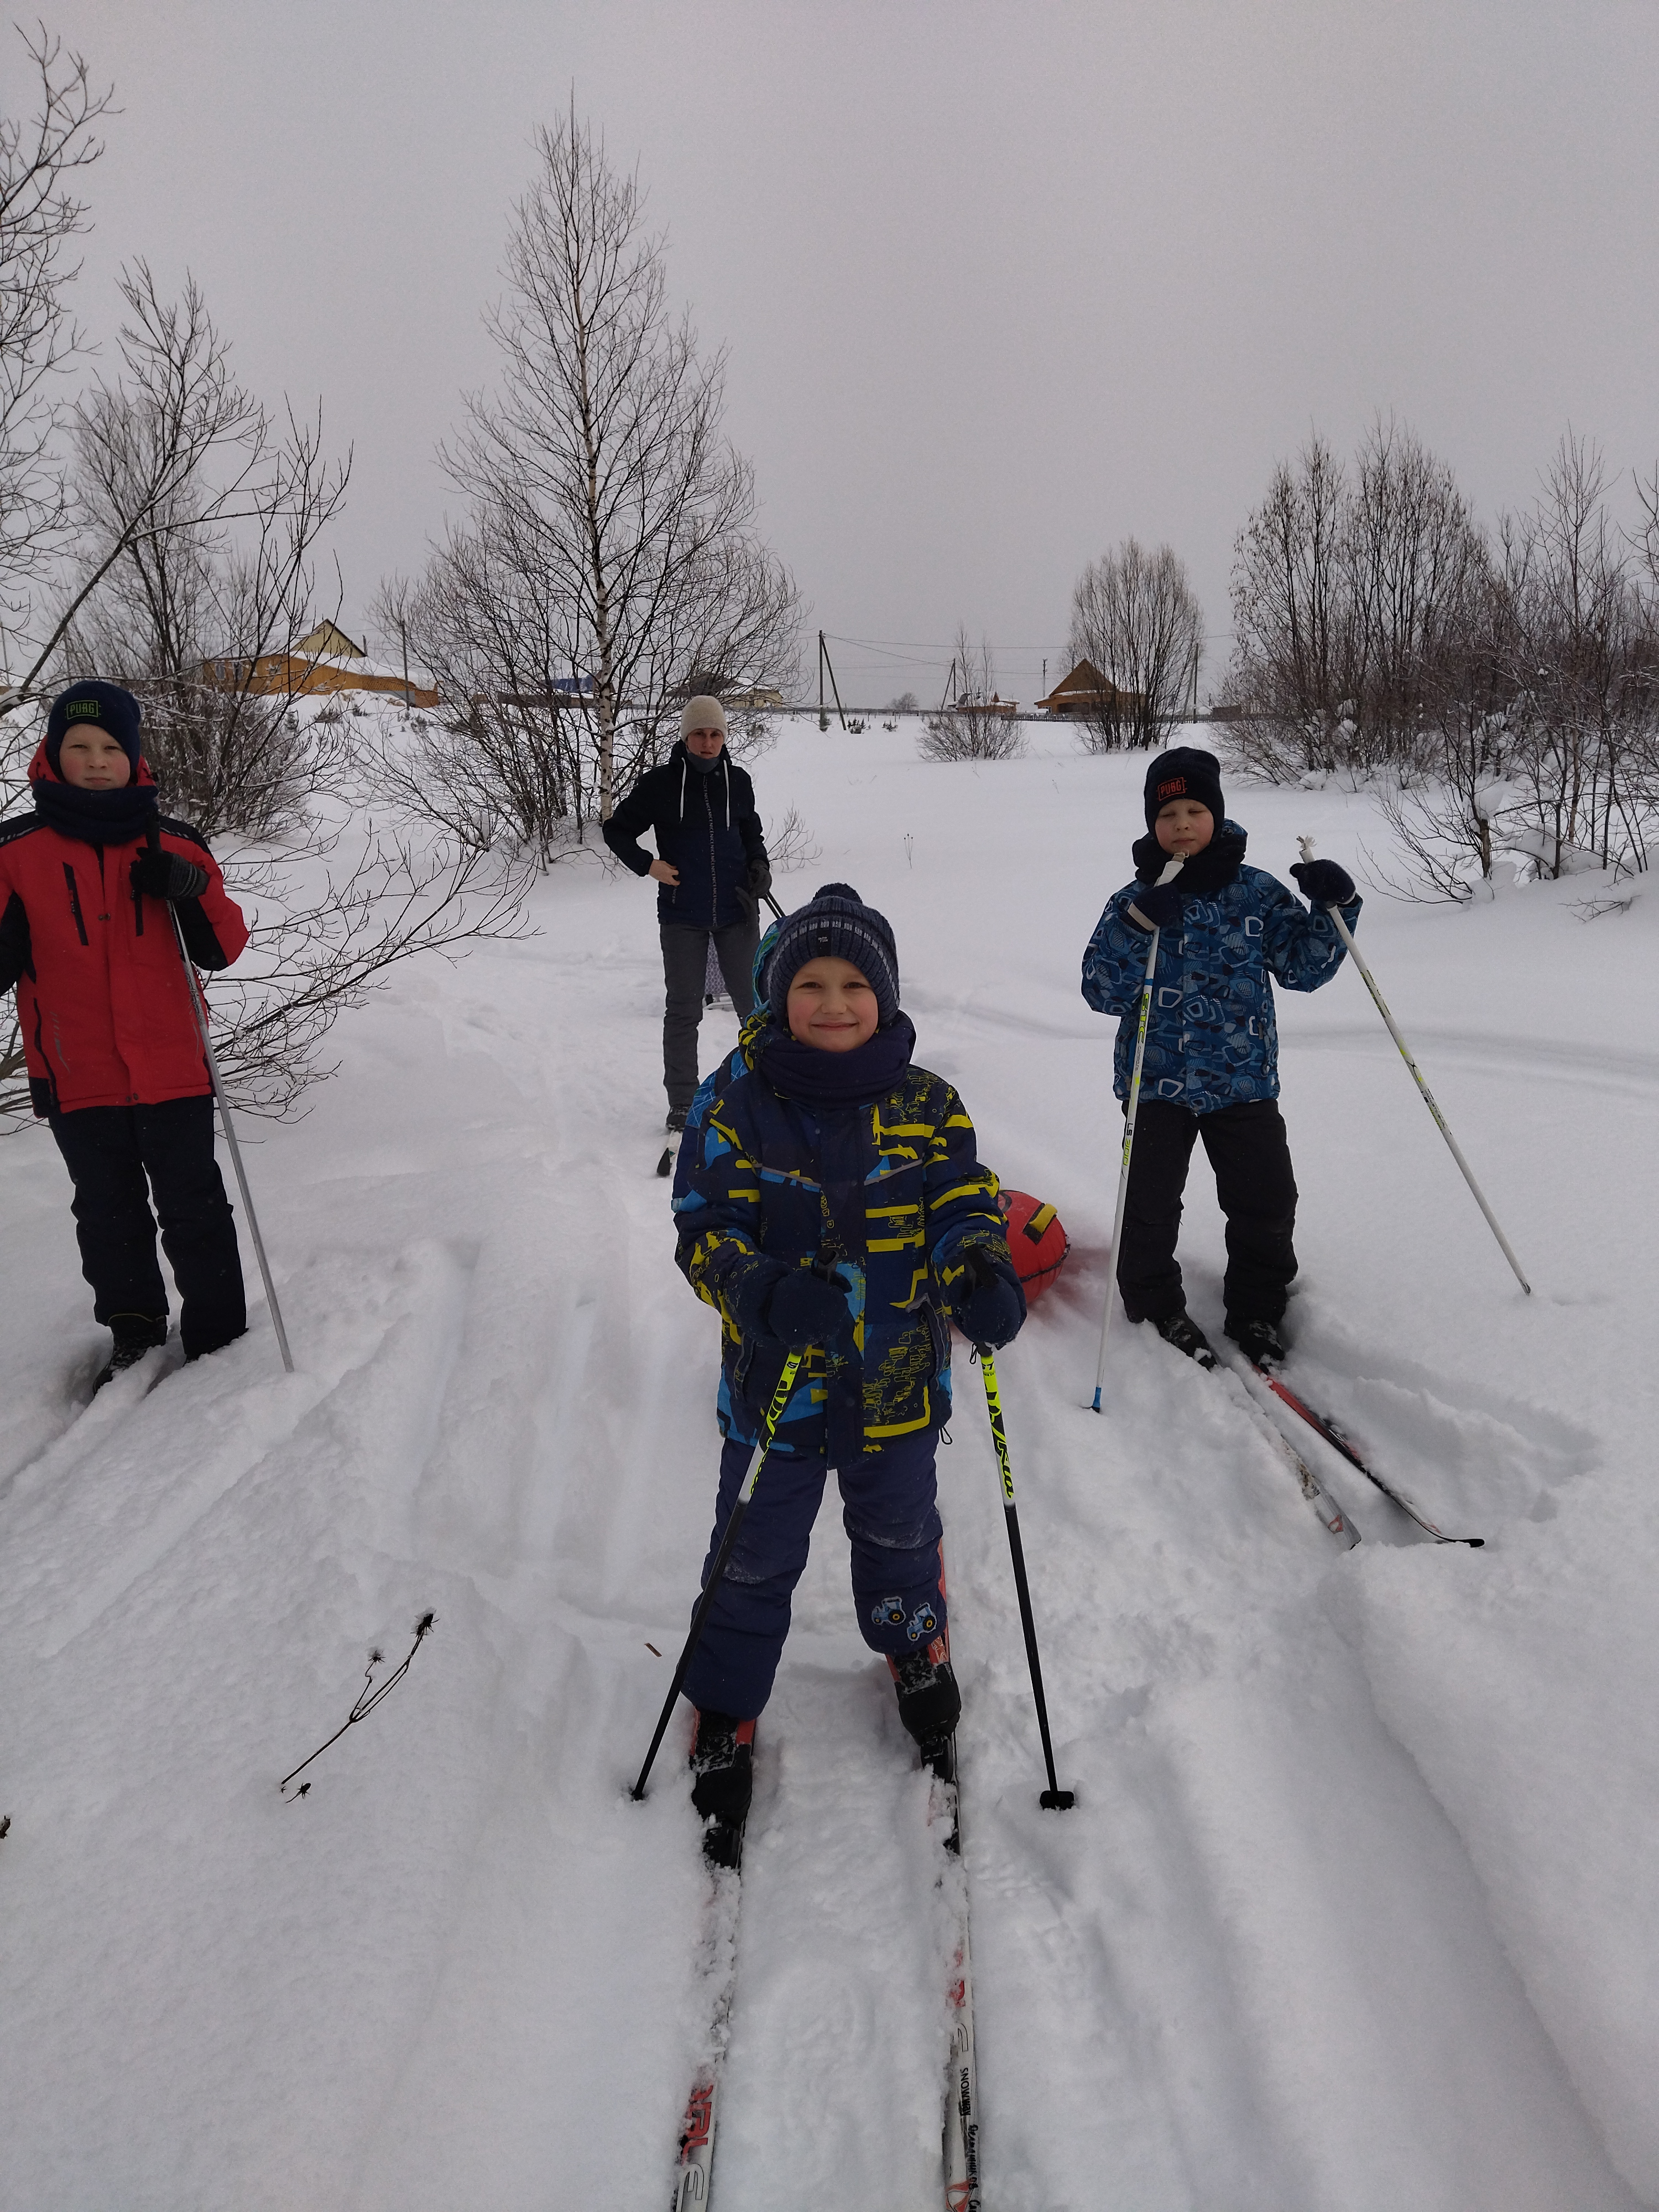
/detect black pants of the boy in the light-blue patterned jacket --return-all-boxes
[1117,1099,1296,1327]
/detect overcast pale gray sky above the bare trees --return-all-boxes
[23,0,1659,703]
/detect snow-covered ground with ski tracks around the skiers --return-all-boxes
[0,726,1659,2212]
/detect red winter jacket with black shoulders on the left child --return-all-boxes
[0,745,248,1115]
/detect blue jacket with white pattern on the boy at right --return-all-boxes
[1084,823,1360,1113]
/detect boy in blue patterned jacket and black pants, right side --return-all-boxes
[1084,745,1360,1367]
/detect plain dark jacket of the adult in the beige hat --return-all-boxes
[604,741,765,929]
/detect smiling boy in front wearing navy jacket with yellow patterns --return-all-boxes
[675,883,1024,1832]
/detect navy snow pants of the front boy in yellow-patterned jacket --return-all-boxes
[686,1429,945,1721]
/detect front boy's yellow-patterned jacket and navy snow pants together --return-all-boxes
[675,1004,1018,1719]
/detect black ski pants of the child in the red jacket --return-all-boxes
[51,1097,248,1358]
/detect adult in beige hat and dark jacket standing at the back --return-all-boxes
[604,699,772,1130]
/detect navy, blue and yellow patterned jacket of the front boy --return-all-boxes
[675,1009,1024,1467]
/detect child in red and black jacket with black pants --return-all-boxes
[0,684,248,1389]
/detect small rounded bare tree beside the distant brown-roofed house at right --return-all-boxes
[1068,538,1203,752]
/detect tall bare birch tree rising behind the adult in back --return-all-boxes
[440,108,799,836]
